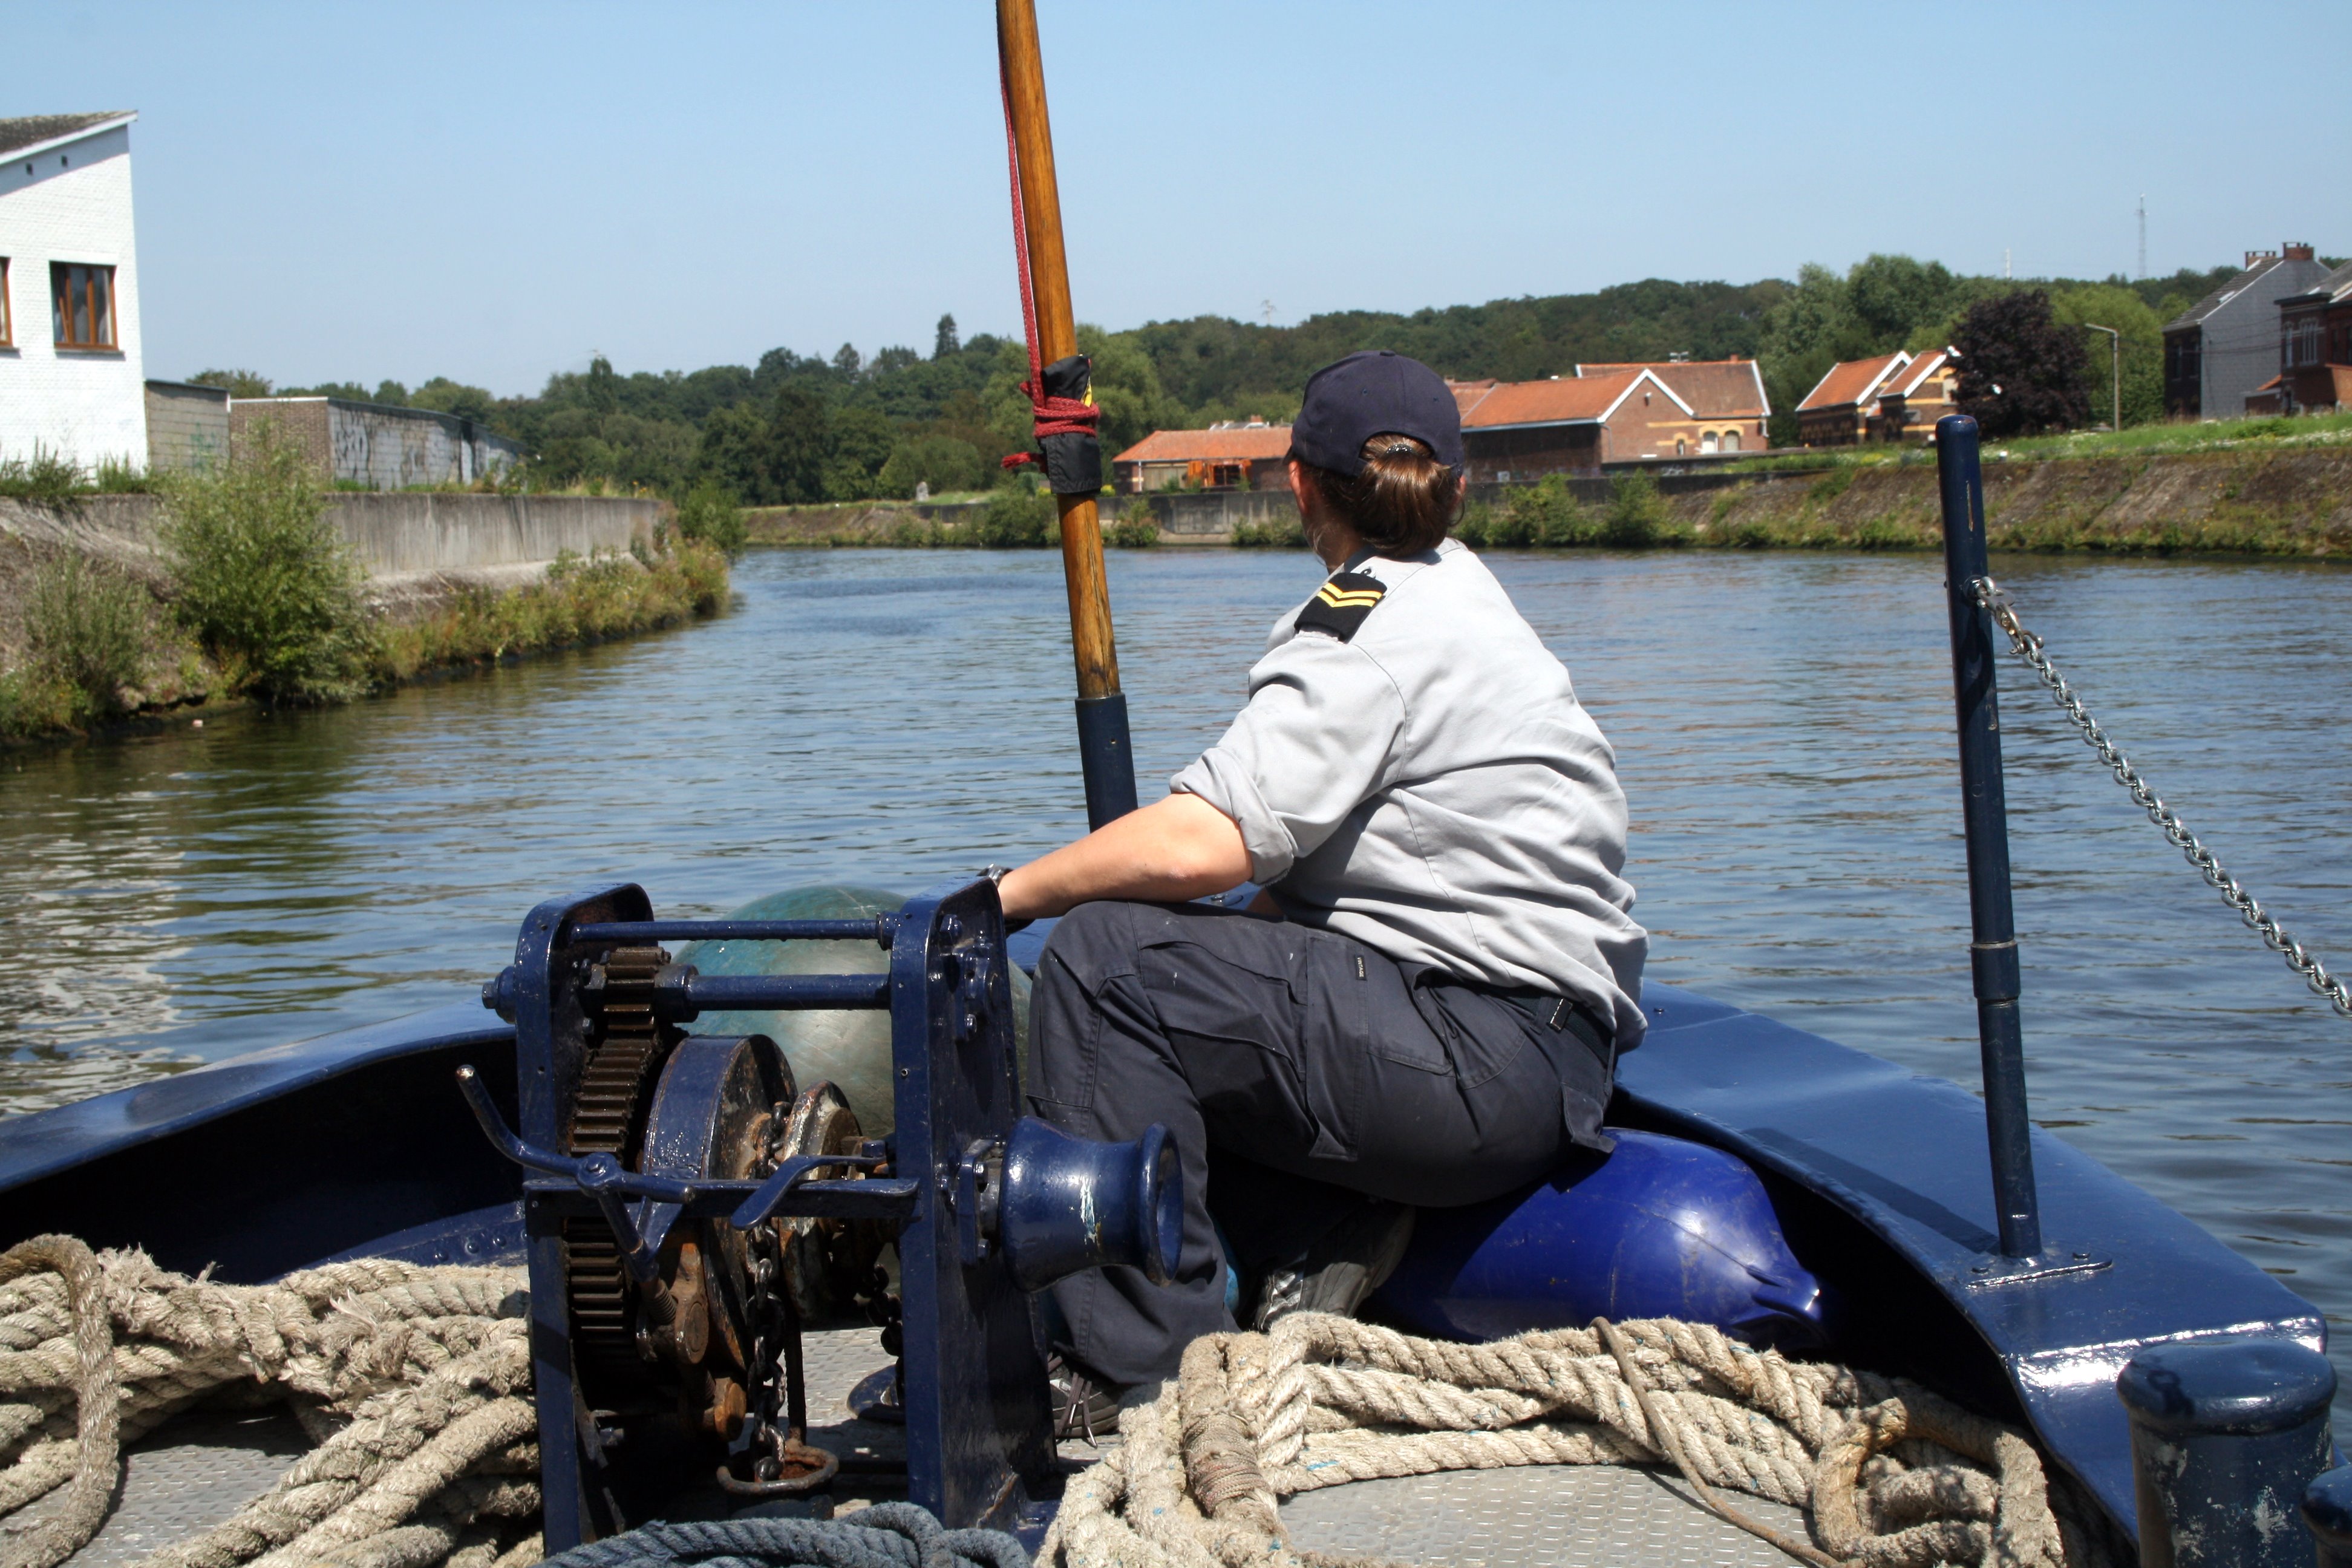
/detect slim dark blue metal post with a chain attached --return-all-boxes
[1936,414,2042,1258]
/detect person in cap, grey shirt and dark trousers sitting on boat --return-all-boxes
[999,353,1648,1399]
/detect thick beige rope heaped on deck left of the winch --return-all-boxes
[0,1236,538,1568]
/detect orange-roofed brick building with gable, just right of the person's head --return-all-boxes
[1451,367,1703,485]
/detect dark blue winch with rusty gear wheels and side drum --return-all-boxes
[459,877,1183,1554]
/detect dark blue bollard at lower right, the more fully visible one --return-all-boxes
[2114,1338,2336,1568]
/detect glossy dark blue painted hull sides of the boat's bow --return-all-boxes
[0,985,2326,1533]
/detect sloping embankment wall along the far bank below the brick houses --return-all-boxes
[745,446,2352,555]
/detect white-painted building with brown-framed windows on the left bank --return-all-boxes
[0,113,148,468]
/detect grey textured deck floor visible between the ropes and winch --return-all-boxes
[36,1328,1804,1568]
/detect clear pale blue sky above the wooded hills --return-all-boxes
[22,0,2352,393]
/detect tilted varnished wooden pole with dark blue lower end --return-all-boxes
[998,0,1136,828]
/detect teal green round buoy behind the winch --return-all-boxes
[673,884,1030,1138]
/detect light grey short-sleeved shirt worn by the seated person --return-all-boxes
[1169,538,1648,1051]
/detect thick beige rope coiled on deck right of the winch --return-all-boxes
[1042,1314,2129,1568]
